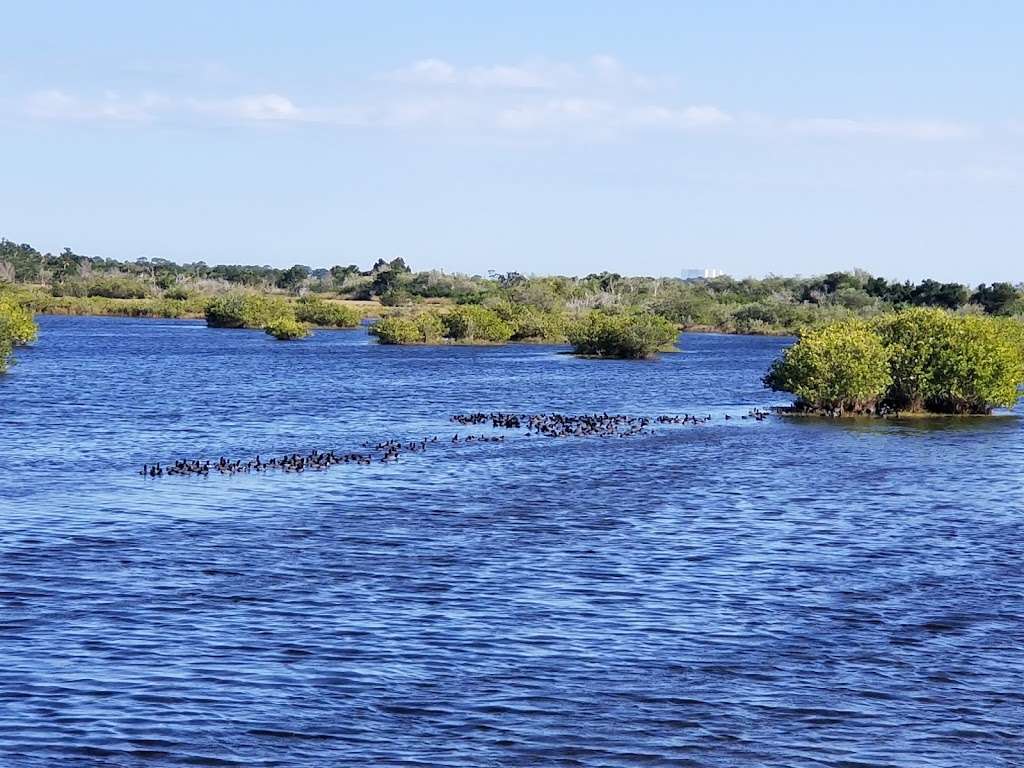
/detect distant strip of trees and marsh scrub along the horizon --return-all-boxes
[0,240,1024,341]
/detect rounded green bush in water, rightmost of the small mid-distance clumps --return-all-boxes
[568,311,679,359]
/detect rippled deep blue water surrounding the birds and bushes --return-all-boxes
[0,317,1024,768]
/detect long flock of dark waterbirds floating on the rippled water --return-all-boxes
[139,409,770,477]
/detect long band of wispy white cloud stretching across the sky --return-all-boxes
[14,55,981,142]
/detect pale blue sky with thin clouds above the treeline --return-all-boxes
[0,0,1024,283]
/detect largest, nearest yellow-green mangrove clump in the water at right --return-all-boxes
[765,309,1024,416]
